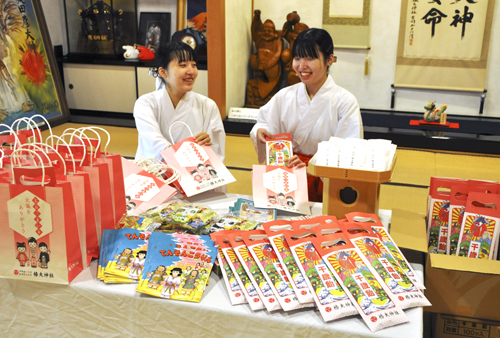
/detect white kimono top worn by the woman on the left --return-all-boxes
[134,86,226,161]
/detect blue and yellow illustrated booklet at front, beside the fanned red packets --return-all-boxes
[137,232,217,302]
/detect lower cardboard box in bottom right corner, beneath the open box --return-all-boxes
[432,314,500,338]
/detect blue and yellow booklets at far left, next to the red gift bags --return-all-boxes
[97,228,151,283]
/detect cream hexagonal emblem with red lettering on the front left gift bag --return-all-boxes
[7,191,52,240]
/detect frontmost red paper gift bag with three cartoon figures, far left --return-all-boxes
[0,161,83,284]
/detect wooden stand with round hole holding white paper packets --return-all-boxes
[307,156,396,219]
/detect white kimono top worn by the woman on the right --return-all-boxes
[250,75,363,163]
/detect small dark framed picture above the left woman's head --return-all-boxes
[137,12,171,49]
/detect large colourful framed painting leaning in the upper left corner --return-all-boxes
[0,0,69,132]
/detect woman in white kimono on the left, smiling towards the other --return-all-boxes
[134,42,226,161]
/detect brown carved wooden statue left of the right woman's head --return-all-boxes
[247,10,283,107]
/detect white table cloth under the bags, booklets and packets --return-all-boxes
[0,194,423,338]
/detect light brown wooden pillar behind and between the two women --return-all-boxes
[207,0,226,120]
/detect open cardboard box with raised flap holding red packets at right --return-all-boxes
[390,209,500,321]
